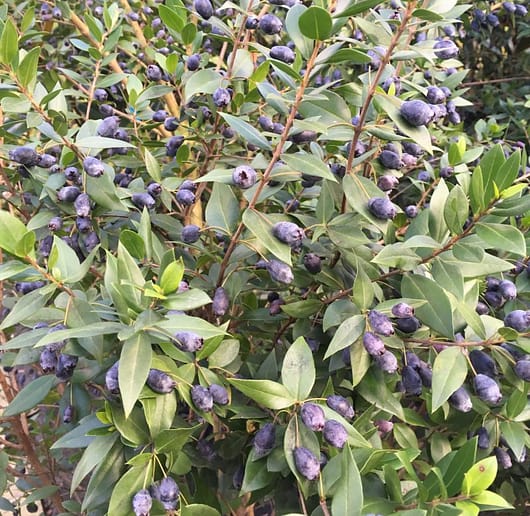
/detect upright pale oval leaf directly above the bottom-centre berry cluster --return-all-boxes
[282,337,316,401]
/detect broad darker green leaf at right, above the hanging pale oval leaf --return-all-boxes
[401,274,454,338]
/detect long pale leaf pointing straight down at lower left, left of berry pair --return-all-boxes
[118,333,152,418]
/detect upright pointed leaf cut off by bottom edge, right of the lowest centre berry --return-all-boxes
[331,446,364,516]
